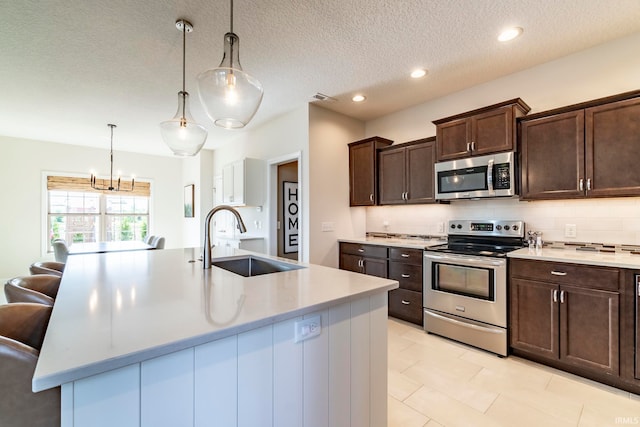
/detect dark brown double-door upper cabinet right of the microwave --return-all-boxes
[519,91,640,200]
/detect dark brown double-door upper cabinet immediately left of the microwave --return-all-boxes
[378,137,435,205]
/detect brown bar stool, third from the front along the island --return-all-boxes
[4,274,61,305]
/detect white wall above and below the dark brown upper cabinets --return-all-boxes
[362,34,640,244]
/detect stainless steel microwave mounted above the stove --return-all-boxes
[435,151,517,200]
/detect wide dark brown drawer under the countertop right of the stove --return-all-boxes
[510,259,620,291]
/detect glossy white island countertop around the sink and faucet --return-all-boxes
[32,247,398,391]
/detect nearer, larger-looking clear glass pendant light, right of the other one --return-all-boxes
[198,0,263,129]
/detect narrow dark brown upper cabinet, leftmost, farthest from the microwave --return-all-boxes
[349,136,393,206]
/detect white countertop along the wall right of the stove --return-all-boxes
[507,248,640,269]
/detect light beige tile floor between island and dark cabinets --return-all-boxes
[388,318,640,427]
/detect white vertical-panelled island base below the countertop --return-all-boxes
[62,291,387,427]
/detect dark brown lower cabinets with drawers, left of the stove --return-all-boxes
[340,242,423,326]
